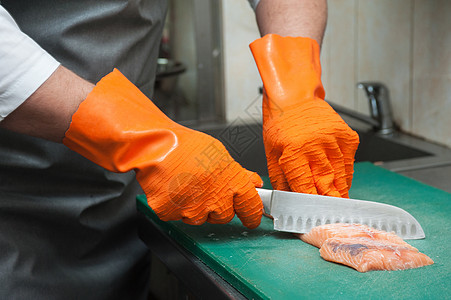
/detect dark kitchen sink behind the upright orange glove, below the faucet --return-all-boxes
[194,117,451,176]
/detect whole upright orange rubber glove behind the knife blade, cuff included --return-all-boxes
[250,35,359,197]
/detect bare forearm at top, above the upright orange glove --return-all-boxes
[255,0,327,45]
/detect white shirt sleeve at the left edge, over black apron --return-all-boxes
[0,5,59,121]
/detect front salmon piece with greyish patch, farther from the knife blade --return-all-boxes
[319,237,434,272]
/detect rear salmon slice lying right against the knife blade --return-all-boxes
[299,223,417,250]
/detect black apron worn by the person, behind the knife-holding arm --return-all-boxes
[0,0,167,300]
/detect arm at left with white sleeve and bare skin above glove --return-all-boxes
[0,5,93,142]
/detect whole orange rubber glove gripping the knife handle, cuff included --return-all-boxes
[63,70,263,228]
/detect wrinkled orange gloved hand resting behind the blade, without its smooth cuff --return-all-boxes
[263,99,359,197]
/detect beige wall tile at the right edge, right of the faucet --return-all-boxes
[412,0,451,147]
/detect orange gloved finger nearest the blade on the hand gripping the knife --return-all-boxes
[233,182,263,229]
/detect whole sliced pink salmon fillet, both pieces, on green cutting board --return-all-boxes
[298,223,434,272]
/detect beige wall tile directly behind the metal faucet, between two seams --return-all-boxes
[357,0,413,130]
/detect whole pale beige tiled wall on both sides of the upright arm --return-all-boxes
[223,0,451,147]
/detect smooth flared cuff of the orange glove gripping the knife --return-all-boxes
[63,69,179,172]
